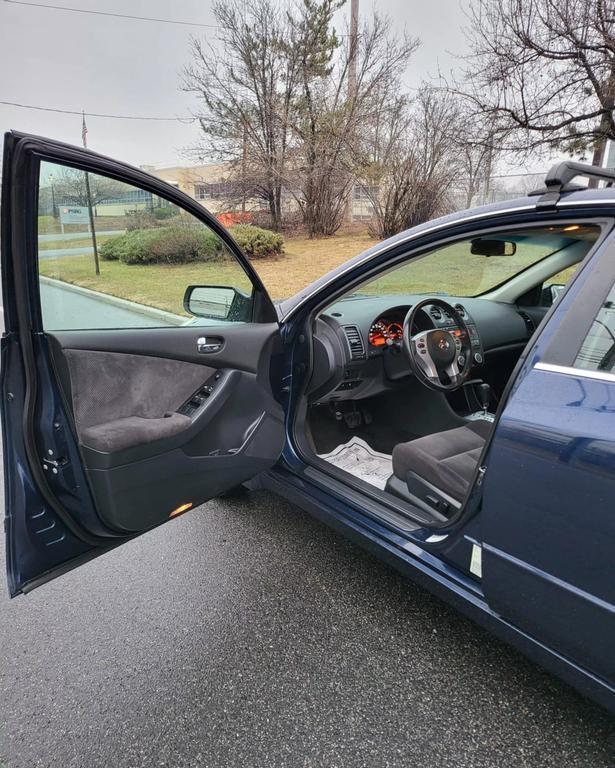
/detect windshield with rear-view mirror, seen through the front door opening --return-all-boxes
[355,224,600,298]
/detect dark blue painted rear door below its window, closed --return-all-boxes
[483,370,615,683]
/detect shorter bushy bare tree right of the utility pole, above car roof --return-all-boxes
[360,88,459,237]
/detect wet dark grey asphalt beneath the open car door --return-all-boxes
[0,491,615,768]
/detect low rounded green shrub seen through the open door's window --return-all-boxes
[100,227,227,264]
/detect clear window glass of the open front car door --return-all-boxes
[38,162,252,331]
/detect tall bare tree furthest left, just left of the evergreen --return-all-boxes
[183,0,296,229]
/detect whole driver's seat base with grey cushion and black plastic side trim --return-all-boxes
[386,419,493,514]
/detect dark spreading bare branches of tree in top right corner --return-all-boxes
[459,0,615,164]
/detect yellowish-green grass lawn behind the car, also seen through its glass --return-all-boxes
[40,226,568,315]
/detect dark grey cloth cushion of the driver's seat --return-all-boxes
[393,420,493,501]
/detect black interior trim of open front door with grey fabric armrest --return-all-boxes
[46,342,283,533]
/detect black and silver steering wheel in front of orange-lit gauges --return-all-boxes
[402,298,472,392]
